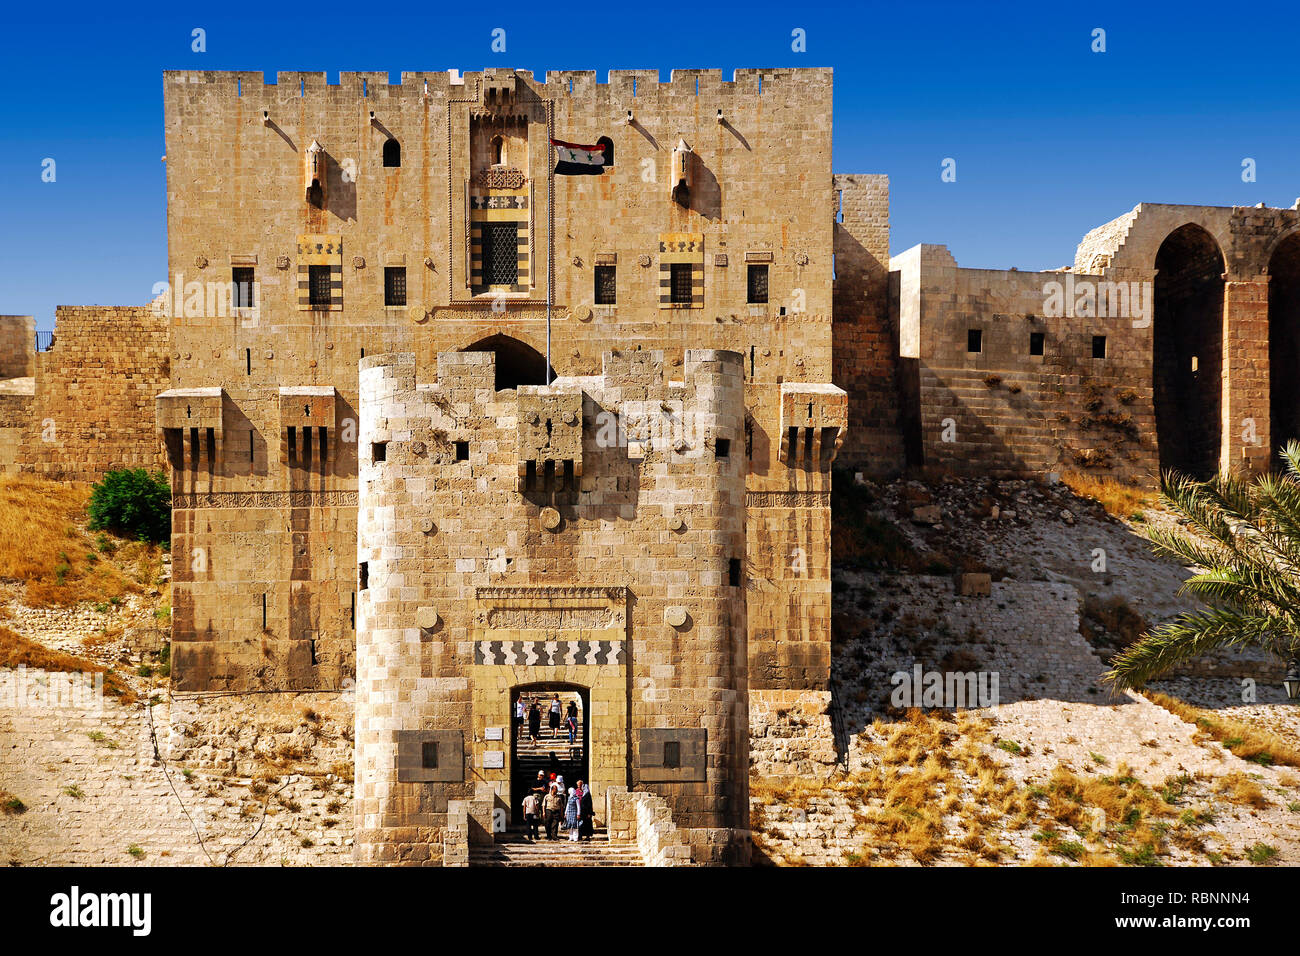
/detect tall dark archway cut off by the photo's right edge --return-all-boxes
[1269,233,1300,460]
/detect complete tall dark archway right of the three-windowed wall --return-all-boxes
[1152,222,1225,479]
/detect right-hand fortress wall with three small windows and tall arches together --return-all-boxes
[891,203,1300,480]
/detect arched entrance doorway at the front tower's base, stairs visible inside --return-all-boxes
[510,683,592,826]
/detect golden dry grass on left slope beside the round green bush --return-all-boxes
[0,475,163,607]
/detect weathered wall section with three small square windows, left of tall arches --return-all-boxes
[891,246,1156,477]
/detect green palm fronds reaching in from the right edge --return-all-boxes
[1104,441,1300,689]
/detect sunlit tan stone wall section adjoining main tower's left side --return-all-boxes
[18,306,170,481]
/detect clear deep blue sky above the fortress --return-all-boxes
[0,0,1300,329]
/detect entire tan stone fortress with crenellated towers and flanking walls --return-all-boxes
[0,63,1300,865]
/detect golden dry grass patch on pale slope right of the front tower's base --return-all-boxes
[750,710,1216,866]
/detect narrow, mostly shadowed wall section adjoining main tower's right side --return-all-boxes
[832,176,905,476]
